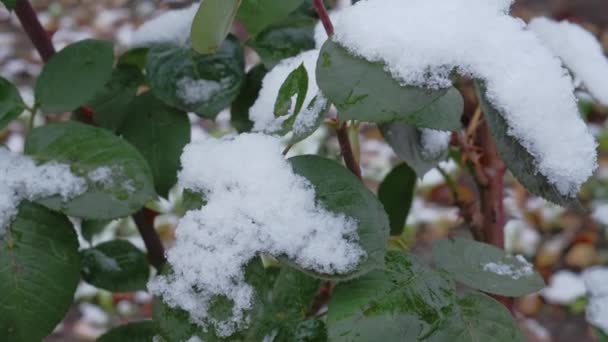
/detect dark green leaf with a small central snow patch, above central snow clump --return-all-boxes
[146,35,245,118]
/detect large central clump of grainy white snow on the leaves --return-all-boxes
[148,134,365,336]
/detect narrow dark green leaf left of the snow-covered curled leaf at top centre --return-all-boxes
[230,64,268,133]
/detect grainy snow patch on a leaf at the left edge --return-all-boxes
[0,148,86,236]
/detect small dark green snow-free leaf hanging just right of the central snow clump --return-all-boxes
[378,163,417,235]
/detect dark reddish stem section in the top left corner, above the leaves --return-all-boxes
[15,0,55,63]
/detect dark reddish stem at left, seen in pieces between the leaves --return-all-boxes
[15,0,165,269]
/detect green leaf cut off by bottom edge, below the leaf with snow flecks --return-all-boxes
[431,293,525,342]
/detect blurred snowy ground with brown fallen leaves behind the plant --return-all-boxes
[0,0,608,342]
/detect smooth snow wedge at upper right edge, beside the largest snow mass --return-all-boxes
[528,18,608,105]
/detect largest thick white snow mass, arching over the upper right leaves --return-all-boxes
[333,0,597,197]
